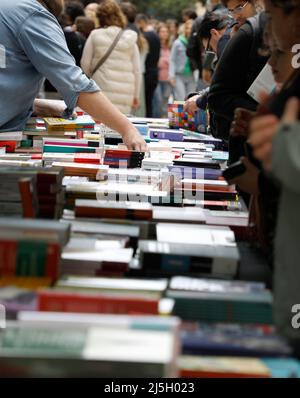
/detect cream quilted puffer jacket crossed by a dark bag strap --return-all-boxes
[81,26,141,114]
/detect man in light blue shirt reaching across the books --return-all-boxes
[0,0,146,150]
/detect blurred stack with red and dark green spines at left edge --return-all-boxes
[0,218,70,281]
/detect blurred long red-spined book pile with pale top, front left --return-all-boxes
[38,277,173,315]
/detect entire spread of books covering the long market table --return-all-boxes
[0,109,300,377]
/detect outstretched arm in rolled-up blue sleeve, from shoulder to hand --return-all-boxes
[18,11,146,150]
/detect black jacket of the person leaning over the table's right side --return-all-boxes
[208,13,267,163]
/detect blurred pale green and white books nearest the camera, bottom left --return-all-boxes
[0,314,178,378]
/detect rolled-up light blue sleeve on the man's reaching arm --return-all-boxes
[18,10,100,110]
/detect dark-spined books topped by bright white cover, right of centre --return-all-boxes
[133,223,239,279]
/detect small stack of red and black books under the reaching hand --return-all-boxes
[104,149,145,169]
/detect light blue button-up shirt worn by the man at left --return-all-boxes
[0,0,100,132]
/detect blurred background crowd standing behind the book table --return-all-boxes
[46,0,224,117]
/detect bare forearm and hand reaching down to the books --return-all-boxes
[77,92,147,151]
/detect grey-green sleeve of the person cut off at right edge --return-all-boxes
[272,123,300,193]
